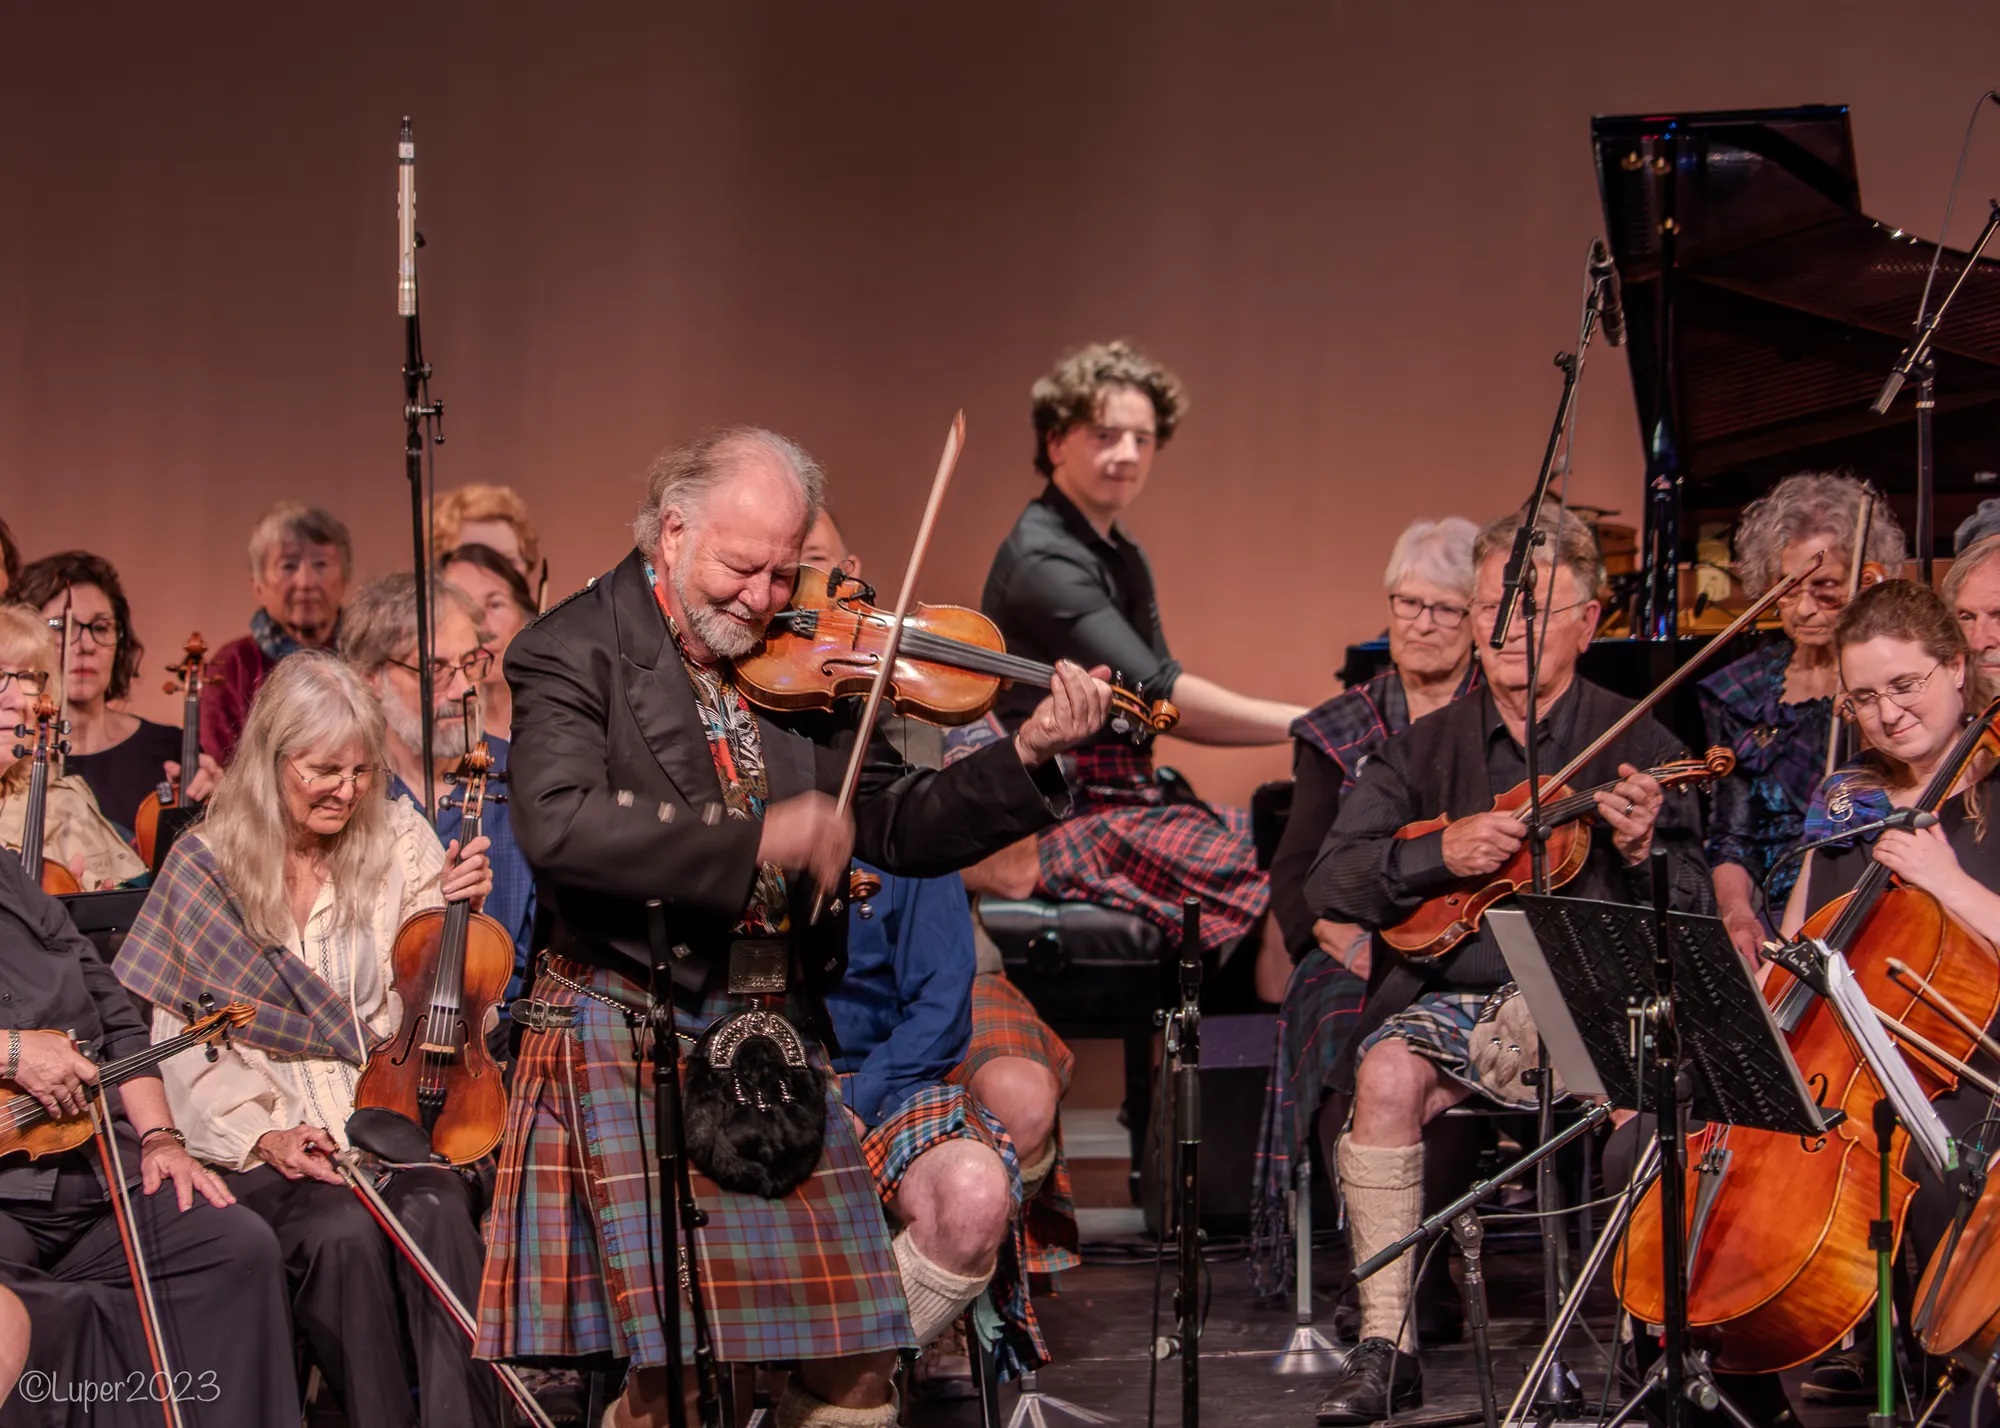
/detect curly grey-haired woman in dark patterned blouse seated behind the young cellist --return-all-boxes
[1696,472,1906,956]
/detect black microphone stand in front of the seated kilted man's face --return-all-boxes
[1490,253,1604,1416]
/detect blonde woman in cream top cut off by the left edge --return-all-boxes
[0,604,146,892]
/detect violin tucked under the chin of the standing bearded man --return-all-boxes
[736,566,1180,738]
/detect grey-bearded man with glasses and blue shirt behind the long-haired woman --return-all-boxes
[340,570,536,1062]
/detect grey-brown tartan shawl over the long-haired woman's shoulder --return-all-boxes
[112,834,368,1066]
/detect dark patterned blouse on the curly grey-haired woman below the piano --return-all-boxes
[1696,640,1834,910]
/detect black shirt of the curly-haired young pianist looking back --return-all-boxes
[980,482,1180,740]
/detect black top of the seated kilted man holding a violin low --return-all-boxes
[1306,680,1712,992]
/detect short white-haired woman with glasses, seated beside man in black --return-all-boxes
[1252,516,1480,1320]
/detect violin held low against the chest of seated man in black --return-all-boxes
[1382,748,1736,962]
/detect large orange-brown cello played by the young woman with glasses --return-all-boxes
[1616,700,2000,1374]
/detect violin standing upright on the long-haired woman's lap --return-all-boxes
[354,708,514,1166]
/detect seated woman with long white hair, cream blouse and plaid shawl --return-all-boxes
[116,650,500,1428]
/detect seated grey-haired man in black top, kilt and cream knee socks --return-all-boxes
[1306,512,1710,1424]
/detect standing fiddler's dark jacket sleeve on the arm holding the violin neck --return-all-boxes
[818,734,1070,878]
